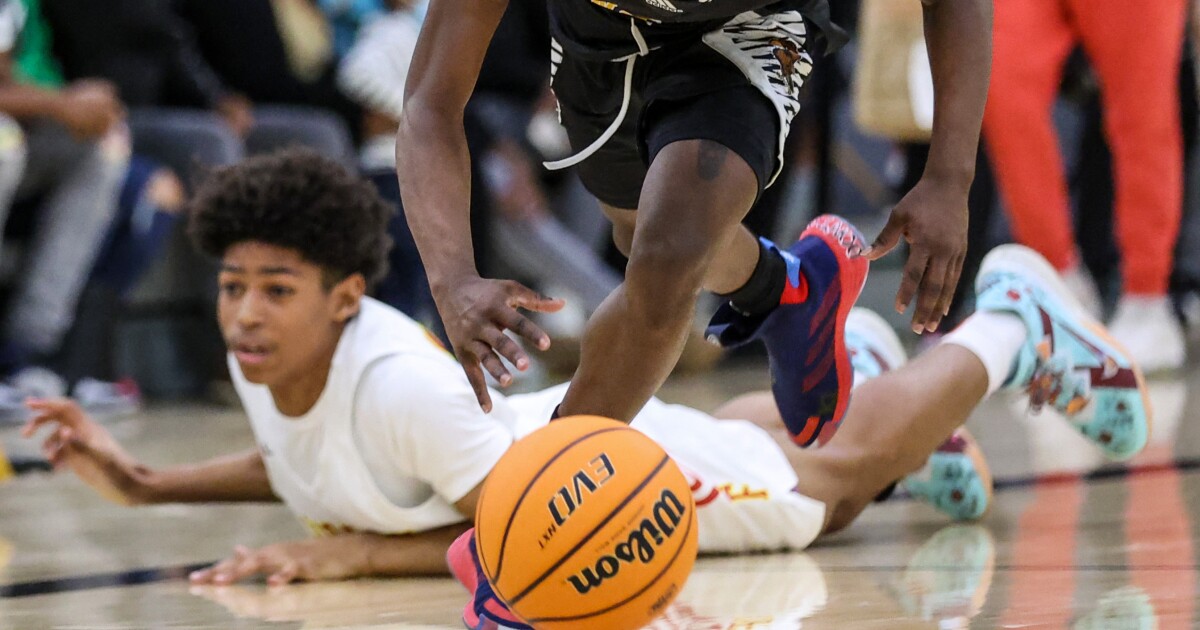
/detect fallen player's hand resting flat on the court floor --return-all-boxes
[188,534,370,586]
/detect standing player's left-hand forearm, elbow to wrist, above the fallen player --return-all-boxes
[396,105,479,290]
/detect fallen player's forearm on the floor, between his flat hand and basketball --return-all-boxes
[350,522,470,577]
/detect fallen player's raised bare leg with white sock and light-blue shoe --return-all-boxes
[718,245,1152,533]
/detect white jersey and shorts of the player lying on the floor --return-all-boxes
[229,299,824,552]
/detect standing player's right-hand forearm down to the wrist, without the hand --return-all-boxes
[924,0,991,188]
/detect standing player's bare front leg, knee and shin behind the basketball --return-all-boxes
[559,140,758,422]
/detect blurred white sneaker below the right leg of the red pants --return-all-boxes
[1109,295,1186,372]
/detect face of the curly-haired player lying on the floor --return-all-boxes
[217,241,362,391]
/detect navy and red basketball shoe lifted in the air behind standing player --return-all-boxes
[708,215,869,446]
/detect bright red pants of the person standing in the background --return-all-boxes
[984,0,1187,295]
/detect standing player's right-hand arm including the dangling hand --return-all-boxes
[868,0,991,332]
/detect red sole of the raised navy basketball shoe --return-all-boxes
[792,215,871,446]
